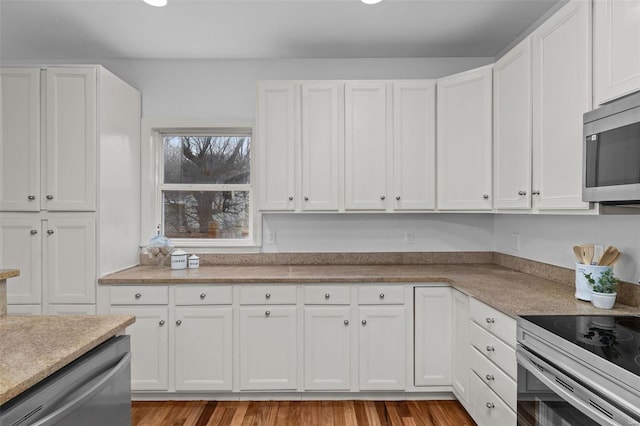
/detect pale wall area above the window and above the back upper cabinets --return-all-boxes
[79,58,493,122]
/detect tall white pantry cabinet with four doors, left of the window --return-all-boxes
[0,65,140,314]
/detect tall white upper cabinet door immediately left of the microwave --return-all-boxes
[532,1,591,210]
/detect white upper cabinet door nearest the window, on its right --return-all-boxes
[256,82,299,211]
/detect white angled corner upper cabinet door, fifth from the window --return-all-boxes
[437,66,492,210]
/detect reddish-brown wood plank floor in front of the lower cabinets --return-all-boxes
[131,401,475,426]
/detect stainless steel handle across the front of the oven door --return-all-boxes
[516,349,638,426]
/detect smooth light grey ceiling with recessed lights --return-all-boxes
[0,0,562,61]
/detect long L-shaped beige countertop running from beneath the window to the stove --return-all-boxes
[99,264,640,317]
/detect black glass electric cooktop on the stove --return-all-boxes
[522,315,640,376]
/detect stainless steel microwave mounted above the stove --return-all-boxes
[582,92,640,205]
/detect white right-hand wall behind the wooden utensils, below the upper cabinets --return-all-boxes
[494,214,640,283]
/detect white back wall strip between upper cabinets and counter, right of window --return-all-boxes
[262,213,494,252]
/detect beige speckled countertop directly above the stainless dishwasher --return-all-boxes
[0,315,135,405]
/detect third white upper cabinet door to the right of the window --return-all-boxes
[345,81,388,210]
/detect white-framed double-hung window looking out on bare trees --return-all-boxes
[142,120,259,252]
